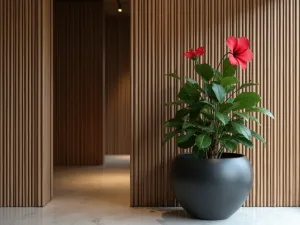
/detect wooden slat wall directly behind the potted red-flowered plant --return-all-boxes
[131,0,300,206]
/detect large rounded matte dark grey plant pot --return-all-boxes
[171,153,253,220]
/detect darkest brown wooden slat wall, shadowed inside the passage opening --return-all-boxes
[54,0,104,165]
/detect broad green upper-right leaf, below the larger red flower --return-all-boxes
[233,92,260,110]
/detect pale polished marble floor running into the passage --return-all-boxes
[0,156,300,225]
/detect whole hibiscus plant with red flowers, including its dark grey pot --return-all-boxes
[163,37,273,220]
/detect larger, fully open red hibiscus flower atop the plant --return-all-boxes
[226,36,253,69]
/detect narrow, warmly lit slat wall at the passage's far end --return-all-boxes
[105,16,131,155]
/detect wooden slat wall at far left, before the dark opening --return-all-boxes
[0,0,52,206]
